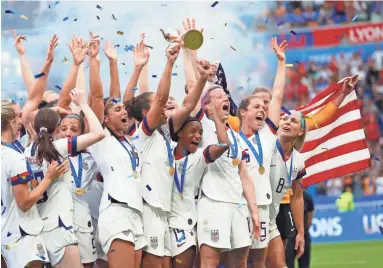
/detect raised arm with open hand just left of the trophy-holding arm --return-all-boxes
[124,34,149,102]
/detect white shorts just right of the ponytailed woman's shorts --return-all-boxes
[74,231,98,263]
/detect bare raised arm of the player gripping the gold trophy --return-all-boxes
[146,45,180,130]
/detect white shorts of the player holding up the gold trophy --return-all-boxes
[144,203,172,257]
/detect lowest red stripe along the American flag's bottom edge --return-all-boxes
[302,159,370,187]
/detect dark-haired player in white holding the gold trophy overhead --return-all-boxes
[124,45,180,268]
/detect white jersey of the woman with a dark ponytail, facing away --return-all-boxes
[24,137,77,231]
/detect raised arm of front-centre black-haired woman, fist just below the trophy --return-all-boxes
[172,61,210,133]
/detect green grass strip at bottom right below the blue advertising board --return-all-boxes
[310,240,383,268]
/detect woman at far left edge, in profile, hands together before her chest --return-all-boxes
[1,102,68,268]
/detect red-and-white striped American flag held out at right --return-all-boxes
[297,79,371,186]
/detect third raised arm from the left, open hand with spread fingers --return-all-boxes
[58,35,87,110]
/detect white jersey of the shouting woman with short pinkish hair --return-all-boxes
[197,113,246,204]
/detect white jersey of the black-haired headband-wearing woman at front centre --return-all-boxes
[169,147,209,230]
